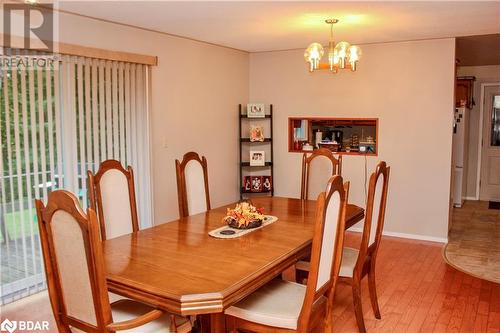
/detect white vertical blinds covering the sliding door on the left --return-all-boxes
[0,53,151,303]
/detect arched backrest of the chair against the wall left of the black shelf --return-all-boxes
[175,152,210,217]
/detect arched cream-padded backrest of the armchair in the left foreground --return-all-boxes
[36,190,112,332]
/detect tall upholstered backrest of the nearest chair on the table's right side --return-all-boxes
[299,175,349,332]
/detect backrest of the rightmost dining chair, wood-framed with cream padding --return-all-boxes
[354,161,391,274]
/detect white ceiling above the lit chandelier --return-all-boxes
[59,1,500,52]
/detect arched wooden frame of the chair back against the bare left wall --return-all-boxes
[175,151,210,217]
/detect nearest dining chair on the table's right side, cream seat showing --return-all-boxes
[224,176,349,333]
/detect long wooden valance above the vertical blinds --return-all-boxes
[0,34,158,66]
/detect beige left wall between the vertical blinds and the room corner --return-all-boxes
[59,14,249,223]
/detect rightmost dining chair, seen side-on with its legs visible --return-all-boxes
[339,161,391,333]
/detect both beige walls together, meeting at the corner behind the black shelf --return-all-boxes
[52,11,454,239]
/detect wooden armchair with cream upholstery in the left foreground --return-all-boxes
[36,190,191,333]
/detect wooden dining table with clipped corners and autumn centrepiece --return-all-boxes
[103,197,364,332]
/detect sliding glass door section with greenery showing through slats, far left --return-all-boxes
[0,55,58,303]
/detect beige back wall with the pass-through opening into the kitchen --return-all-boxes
[250,39,455,241]
